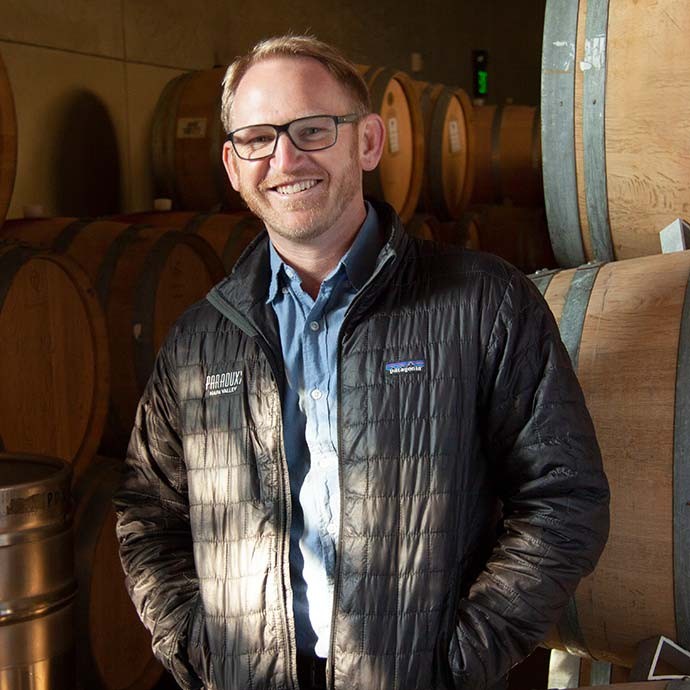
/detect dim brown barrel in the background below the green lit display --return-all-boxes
[472,105,544,206]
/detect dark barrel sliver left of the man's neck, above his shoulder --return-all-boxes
[113,211,264,273]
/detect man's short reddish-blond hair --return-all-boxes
[220,34,371,132]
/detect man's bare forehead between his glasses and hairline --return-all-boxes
[231,57,352,129]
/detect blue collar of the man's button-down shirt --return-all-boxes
[266,201,383,303]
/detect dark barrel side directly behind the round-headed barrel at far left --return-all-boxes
[3,218,225,456]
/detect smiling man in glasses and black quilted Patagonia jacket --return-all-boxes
[116,37,608,690]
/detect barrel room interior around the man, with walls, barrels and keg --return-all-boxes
[0,0,690,690]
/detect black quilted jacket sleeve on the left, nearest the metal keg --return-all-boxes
[114,334,207,690]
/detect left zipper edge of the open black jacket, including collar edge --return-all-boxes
[206,292,298,690]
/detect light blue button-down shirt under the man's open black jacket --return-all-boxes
[268,204,382,657]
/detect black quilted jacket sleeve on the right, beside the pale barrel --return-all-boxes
[449,272,609,688]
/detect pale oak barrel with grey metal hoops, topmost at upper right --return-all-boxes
[541,0,690,267]
